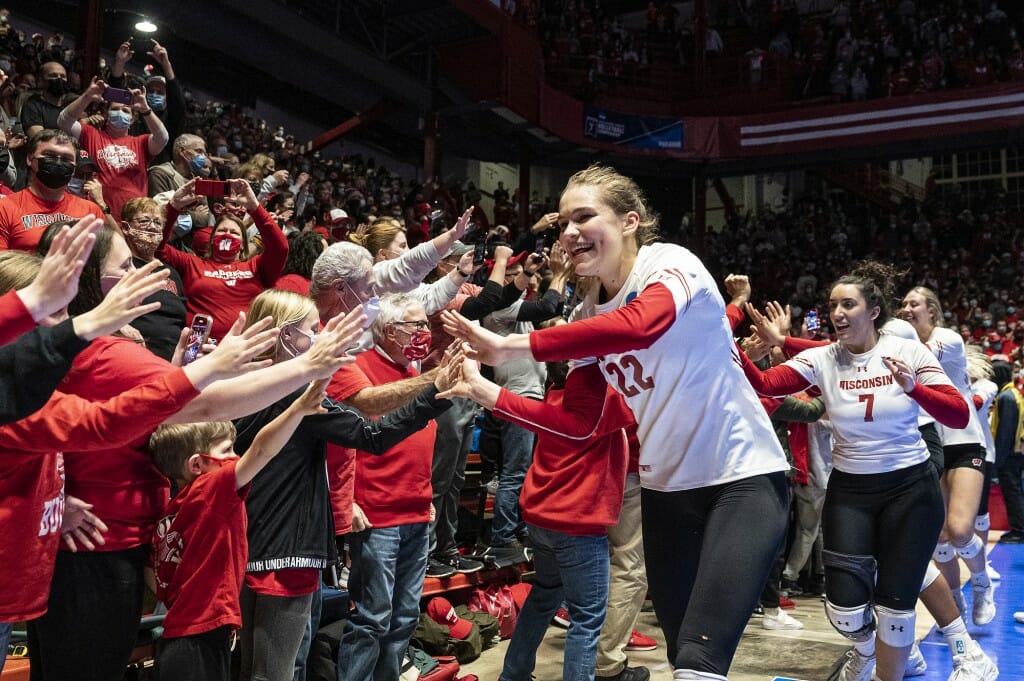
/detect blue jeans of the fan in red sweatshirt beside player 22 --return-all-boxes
[501,525,608,681]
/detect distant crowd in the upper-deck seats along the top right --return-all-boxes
[506,0,1024,101]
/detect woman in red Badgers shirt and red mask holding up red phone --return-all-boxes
[157,179,289,339]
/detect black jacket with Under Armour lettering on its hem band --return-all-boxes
[234,385,452,572]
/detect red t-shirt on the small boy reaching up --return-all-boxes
[150,461,249,638]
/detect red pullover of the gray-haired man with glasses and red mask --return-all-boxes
[354,348,437,527]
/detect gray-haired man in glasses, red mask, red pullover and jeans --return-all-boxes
[338,294,446,679]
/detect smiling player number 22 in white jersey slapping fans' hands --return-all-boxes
[443,166,788,681]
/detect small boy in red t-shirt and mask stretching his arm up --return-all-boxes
[146,381,327,681]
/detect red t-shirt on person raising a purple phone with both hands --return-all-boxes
[78,125,153,221]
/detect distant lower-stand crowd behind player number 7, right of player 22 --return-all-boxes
[707,175,1024,361]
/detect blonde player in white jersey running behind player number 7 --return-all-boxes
[899,286,995,625]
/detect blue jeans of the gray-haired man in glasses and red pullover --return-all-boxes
[338,522,427,681]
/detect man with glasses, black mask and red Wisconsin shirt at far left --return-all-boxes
[0,130,104,253]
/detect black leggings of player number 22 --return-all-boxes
[641,472,790,677]
